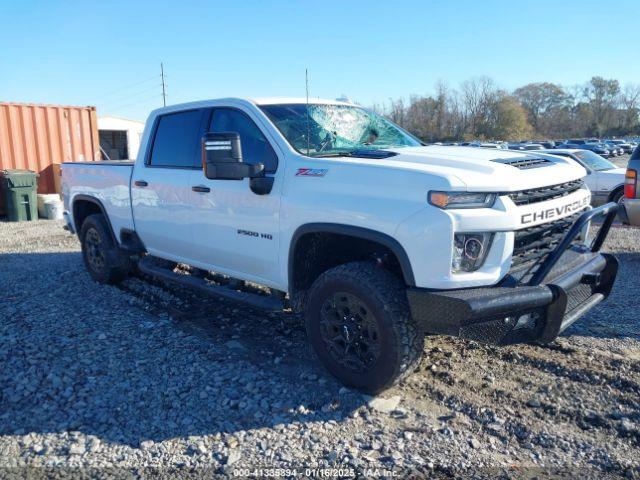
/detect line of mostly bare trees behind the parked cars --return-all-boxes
[382,77,640,141]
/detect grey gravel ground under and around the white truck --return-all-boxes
[0,221,640,478]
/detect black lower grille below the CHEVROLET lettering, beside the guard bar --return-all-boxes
[510,212,582,276]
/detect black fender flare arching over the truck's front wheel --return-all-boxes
[287,223,416,289]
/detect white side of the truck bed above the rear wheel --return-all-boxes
[61,160,134,238]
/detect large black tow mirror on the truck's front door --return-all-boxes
[202,132,264,180]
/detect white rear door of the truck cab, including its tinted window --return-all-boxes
[131,109,207,263]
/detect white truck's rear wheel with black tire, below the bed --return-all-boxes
[80,213,131,284]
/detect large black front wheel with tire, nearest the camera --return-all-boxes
[305,262,424,393]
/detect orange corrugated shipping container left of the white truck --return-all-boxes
[0,102,100,193]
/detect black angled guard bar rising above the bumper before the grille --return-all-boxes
[527,202,619,286]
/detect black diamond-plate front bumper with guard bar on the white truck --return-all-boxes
[407,203,618,345]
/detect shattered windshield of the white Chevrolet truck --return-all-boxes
[261,104,420,157]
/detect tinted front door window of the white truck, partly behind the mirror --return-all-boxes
[209,108,278,173]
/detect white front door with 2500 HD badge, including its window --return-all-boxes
[190,107,281,286]
